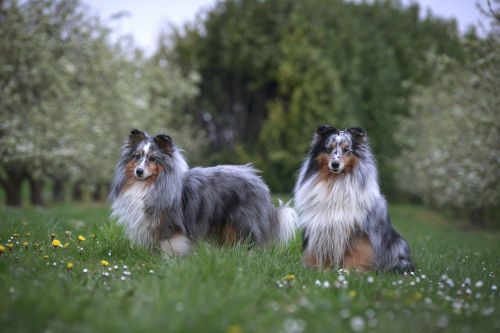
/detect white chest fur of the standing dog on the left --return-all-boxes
[111,183,157,247]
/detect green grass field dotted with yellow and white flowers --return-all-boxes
[0,204,500,333]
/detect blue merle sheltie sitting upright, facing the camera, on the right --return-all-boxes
[294,125,413,272]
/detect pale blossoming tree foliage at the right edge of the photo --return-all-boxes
[397,5,500,225]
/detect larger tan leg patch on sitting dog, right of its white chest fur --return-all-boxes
[342,235,375,272]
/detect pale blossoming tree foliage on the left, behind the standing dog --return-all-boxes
[0,0,203,204]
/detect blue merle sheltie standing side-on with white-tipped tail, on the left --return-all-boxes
[110,129,297,256]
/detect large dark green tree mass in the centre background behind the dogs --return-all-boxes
[166,0,462,191]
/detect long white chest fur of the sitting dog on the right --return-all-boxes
[295,175,380,264]
